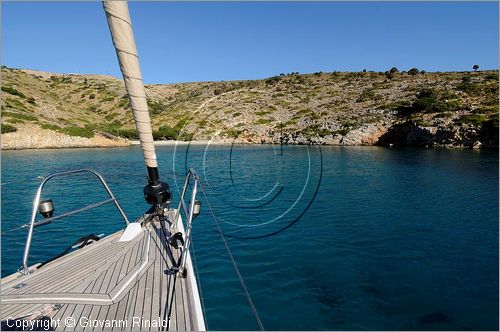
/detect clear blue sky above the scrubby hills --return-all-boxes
[2,1,498,83]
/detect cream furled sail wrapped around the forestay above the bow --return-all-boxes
[102,1,158,168]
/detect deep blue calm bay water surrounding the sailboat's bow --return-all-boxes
[1,146,499,330]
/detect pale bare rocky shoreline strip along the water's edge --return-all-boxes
[1,121,498,150]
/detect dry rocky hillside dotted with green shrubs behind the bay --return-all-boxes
[1,67,498,148]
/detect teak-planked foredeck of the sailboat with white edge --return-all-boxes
[1,211,205,331]
